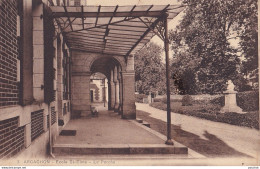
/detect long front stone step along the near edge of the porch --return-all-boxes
[52,144,188,156]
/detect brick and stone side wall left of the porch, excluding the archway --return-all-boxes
[0,0,71,158]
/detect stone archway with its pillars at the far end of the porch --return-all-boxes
[72,50,136,119]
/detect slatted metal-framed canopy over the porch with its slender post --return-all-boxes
[49,0,184,145]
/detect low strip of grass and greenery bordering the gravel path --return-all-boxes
[151,101,259,129]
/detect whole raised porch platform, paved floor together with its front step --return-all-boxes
[53,104,188,156]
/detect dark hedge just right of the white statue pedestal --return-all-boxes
[237,91,259,111]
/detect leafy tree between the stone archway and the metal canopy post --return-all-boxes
[135,42,165,94]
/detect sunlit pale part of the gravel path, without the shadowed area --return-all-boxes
[136,103,260,159]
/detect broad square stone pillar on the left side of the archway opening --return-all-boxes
[71,72,91,116]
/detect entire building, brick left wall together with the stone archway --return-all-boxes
[0,0,136,159]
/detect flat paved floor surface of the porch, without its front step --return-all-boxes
[55,106,164,145]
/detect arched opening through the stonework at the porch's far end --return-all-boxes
[90,57,123,114]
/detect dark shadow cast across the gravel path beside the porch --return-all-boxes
[137,110,251,157]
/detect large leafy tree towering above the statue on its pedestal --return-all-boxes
[170,0,257,94]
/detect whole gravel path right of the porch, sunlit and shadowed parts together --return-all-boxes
[136,103,260,158]
